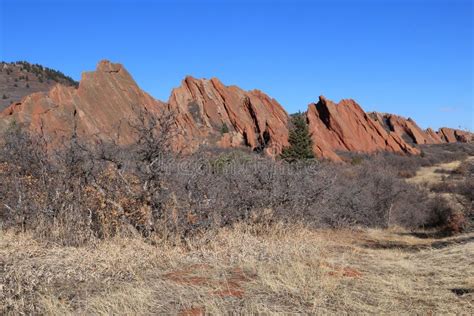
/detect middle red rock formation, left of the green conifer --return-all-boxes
[169,77,288,155]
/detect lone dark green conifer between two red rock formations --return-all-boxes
[281,113,314,162]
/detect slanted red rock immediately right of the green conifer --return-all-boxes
[307,96,419,160]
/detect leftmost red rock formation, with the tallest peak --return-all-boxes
[0,61,165,148]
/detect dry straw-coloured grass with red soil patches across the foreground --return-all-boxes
[0,226,474,315]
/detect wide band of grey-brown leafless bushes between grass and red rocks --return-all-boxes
[0,116,473,245]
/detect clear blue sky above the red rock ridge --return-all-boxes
[0,0,474,130]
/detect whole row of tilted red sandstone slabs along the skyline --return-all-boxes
[0,61,472,161]
